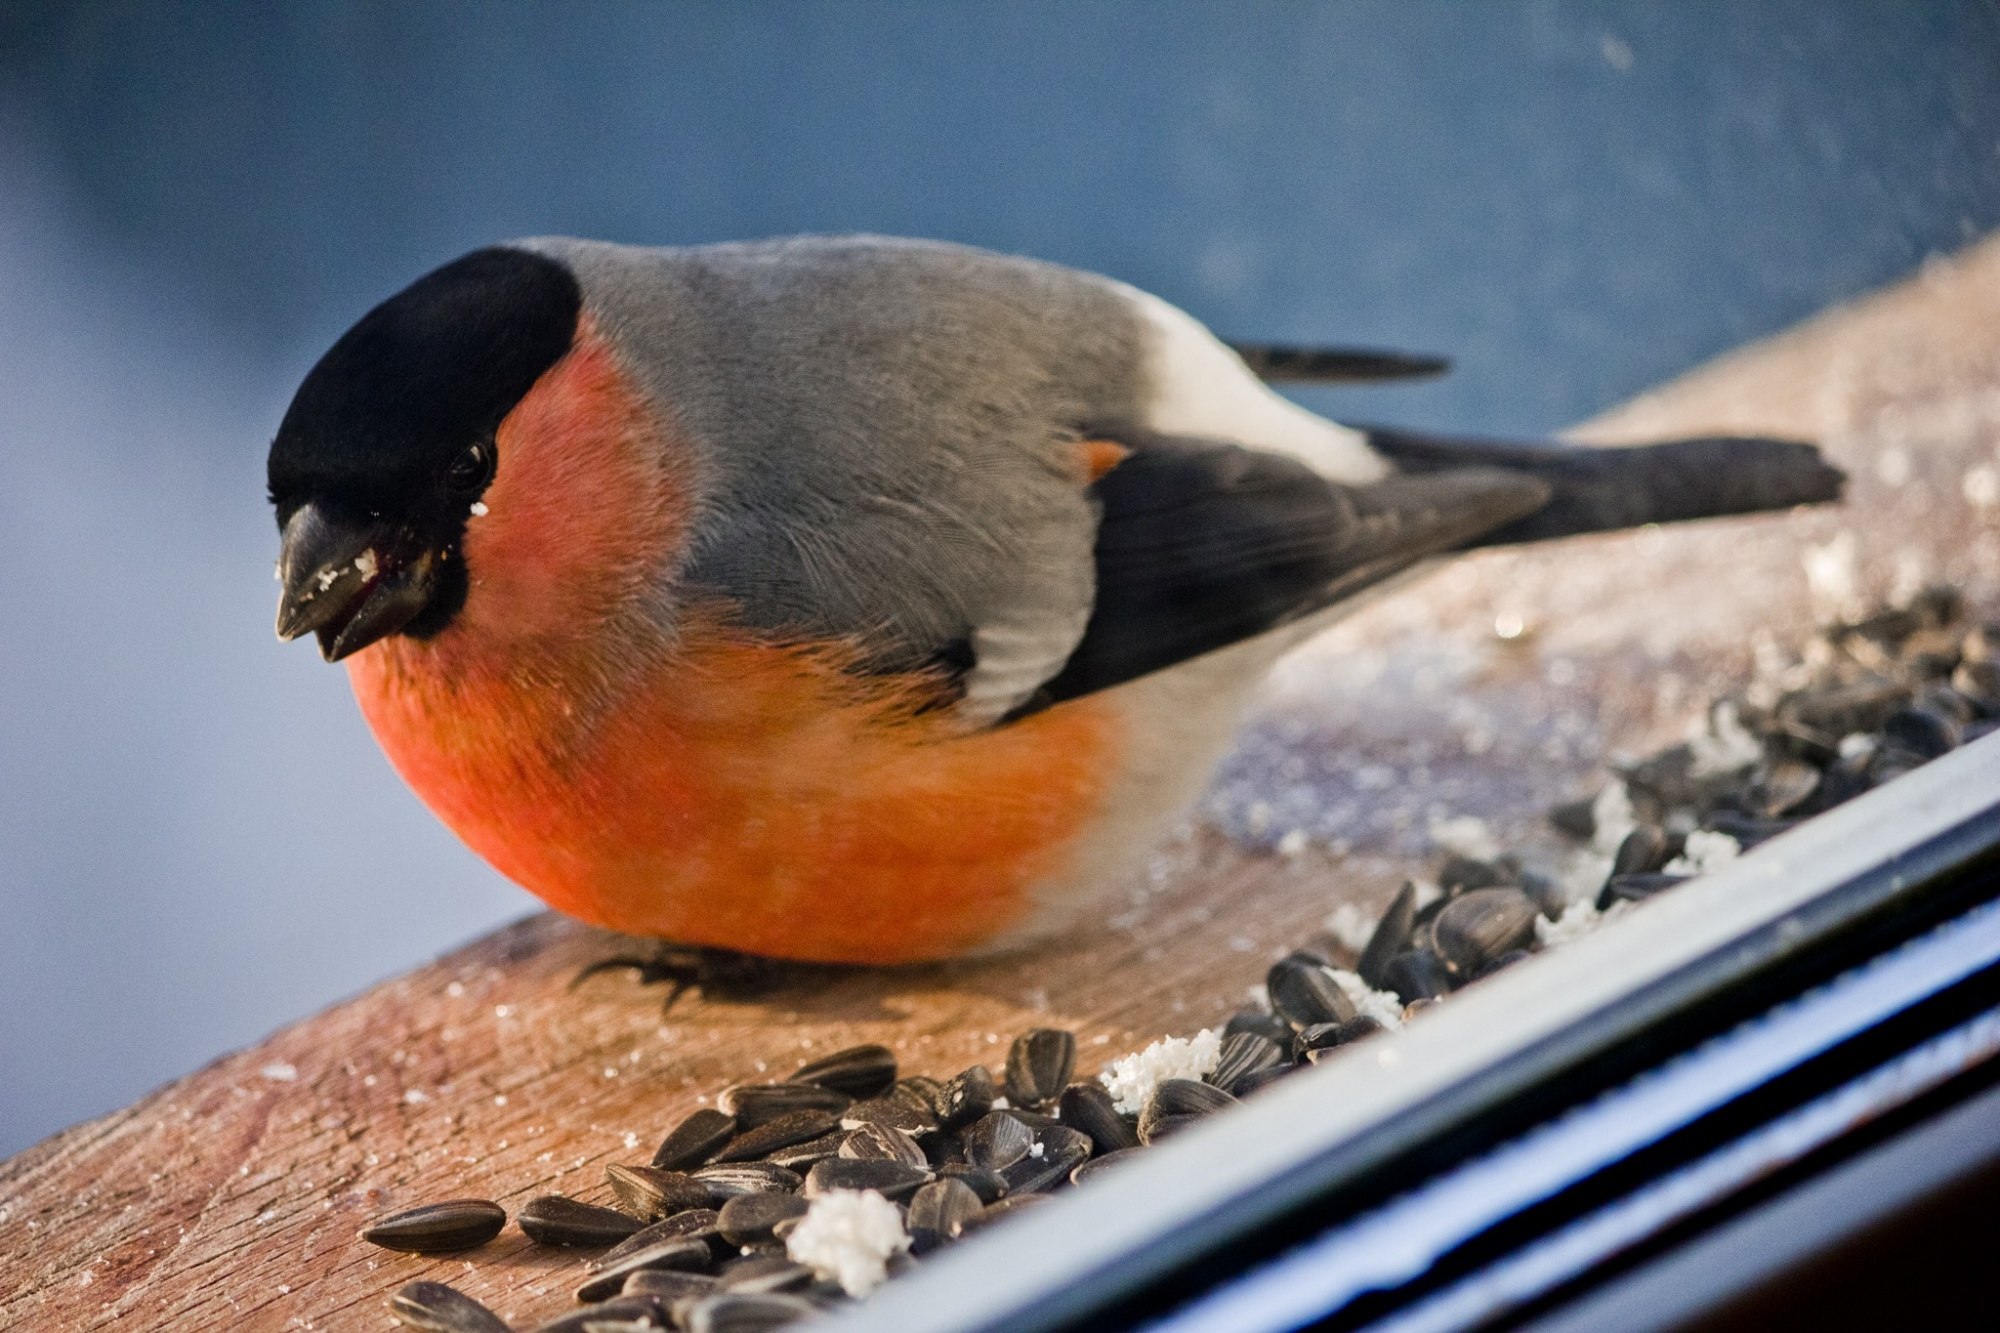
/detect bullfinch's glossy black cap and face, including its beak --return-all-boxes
[268,246,582,656]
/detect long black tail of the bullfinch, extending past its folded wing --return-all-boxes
[1368,428,1846,546]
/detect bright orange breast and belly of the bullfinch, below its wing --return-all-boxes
[350,630,1122,963]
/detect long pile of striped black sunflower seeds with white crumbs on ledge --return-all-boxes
[362,588,2000,1333]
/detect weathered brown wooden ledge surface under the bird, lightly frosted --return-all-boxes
[0,233,2000,1329]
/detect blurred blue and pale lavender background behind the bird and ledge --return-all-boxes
[0,0,2000,1155]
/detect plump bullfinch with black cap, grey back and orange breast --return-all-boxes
[268,236,1844,965]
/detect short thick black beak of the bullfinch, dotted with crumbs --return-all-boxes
[278,504,436,662]
